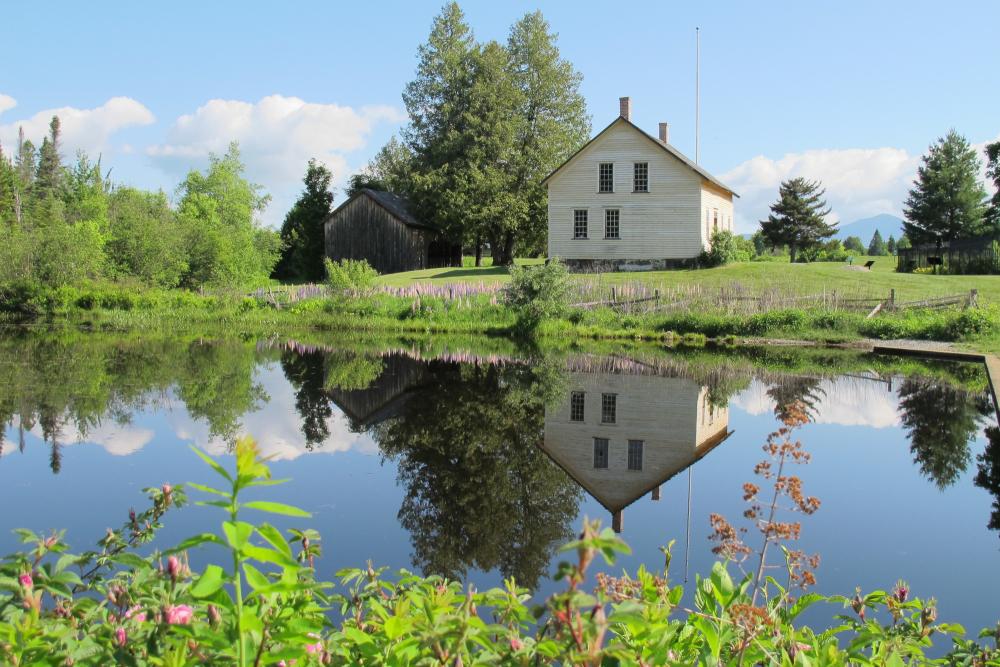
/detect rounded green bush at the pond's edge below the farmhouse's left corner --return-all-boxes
[503,259,570,330]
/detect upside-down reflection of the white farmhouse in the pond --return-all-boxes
[543,372,730,532]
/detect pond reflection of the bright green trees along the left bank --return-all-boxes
[0,335,266,472]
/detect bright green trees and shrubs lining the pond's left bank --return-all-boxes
[0,116,281,288]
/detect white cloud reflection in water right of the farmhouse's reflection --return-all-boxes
[730,377,900,428]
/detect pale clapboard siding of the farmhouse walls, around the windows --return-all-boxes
[548,122,732,260]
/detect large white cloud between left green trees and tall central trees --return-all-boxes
[146,95,405,222]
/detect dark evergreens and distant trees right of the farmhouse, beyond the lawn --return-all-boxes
[758,130,1000,262]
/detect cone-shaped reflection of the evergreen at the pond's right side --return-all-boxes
[899,380,988,489]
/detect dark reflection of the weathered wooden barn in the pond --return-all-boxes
[327,354,427,432]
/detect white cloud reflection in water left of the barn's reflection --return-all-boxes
[169,364,378,461]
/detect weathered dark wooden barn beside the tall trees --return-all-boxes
[324,189,462,273]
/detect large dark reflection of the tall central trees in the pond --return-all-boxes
[374,362,581,586]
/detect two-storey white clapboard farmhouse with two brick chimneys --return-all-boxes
[543,97,739,272]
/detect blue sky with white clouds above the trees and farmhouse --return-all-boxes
[0,0,1000,232]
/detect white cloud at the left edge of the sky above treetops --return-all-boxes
[0,95,156,158]
